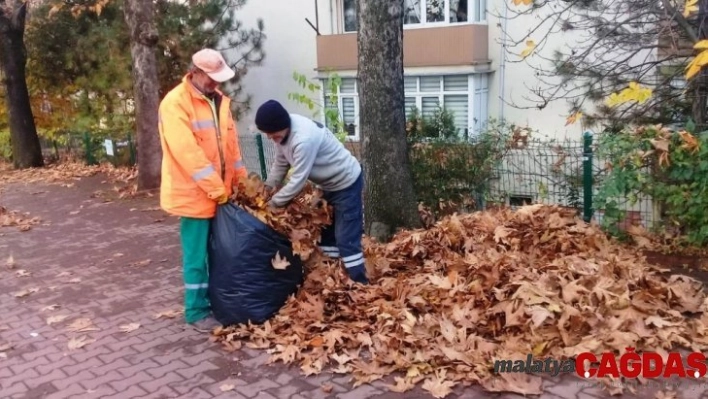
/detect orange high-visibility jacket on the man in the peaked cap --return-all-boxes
[159,74,247,218]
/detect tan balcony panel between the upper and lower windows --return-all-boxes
[317,25,489,71]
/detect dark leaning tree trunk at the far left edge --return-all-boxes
[0,1,44,169]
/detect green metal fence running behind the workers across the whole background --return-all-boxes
[42,132,659,228]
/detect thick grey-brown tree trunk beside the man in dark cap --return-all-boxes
[357,0,421,241]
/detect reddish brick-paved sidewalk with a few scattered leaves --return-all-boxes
[0,177,708,399]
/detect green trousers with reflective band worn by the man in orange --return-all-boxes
[179,217,211,323]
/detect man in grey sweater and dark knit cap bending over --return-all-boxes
[256,100,369,284]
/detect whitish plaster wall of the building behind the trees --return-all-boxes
[227,0,632,140]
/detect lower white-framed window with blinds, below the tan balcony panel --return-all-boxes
[323,74,489,140]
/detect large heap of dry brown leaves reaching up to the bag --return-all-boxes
[213,179,708,397]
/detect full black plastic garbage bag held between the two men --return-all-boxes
[209,203,303,326]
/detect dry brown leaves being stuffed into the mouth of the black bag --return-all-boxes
[231,174,332,260]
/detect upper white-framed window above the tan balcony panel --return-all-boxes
[342,0,487,32]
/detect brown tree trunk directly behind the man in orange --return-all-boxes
[124,0,162,190]
